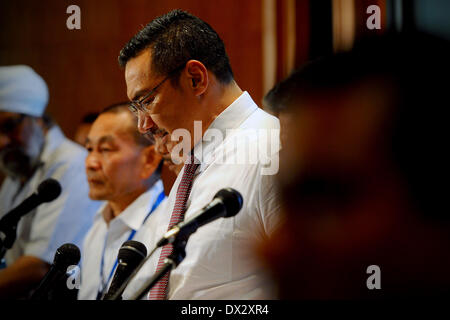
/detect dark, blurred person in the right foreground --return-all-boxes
[262,34,450,299]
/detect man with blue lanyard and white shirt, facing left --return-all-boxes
[78,103,165,300]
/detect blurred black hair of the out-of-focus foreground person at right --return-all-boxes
[265,33,450,221]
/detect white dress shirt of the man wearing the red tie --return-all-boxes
[123,92,280,299]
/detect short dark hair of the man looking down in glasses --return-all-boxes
[119,10,233,84]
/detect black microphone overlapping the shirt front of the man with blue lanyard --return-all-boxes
[102,240,147,300]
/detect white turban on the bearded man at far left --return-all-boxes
[0,65,48,117]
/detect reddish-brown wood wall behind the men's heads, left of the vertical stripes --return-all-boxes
[0,0,263,137]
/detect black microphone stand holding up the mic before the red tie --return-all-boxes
[125,234,190,300]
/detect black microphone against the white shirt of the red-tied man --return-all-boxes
[156,188,244,247]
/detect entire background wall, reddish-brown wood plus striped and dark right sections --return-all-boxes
[0,0,450,187]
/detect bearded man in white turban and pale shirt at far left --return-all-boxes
[0,65,100,299]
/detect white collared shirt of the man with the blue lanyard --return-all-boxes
[78,180,165,300]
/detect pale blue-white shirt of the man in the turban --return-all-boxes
[0,125,101,266]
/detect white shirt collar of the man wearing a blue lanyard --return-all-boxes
[95,179,164,230]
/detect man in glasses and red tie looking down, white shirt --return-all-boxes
[119,10,280,299]
